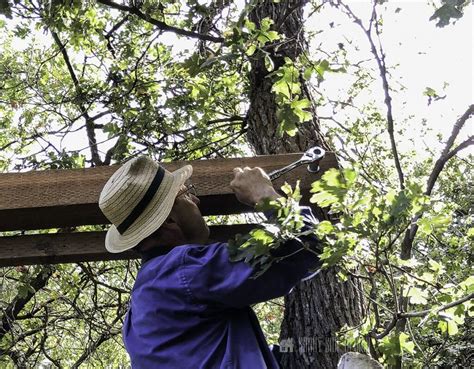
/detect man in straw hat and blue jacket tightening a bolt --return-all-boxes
[99,157,318,369]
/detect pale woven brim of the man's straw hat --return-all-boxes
[105,165,193,253]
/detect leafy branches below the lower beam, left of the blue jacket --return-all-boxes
[0,261,138,368]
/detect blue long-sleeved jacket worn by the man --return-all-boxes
[123,208,319,369]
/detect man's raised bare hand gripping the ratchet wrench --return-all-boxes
[230,167,281,206]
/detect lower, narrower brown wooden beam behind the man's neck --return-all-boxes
[0,224,257,267]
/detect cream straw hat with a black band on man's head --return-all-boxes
[99,156,193,253]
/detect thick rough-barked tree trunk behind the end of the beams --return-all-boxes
[247,0,363,369]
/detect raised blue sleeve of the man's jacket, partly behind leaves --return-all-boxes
[182,208,320,308]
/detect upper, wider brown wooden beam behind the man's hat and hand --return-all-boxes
[0,153,337,231]
